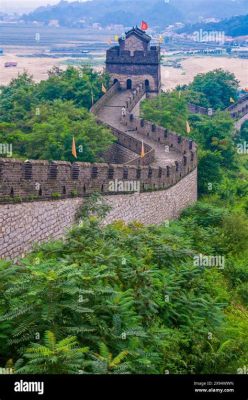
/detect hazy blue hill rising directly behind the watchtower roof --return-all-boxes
[22,0,183,27]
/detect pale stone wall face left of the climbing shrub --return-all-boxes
[0,199,82,259]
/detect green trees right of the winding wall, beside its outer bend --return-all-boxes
[142,70,239,197]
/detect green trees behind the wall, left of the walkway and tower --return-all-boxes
[0,68,114,162]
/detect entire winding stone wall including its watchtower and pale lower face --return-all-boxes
[0,29,248,259]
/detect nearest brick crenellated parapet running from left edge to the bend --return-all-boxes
[0,154,195,202]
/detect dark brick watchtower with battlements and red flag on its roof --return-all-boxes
[106,27,161,93]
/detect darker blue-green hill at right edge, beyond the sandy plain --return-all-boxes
[178,15,248,37]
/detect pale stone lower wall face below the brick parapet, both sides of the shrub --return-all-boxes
[0,169,197,259]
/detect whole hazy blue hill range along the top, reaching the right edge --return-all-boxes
[22,0,248,29]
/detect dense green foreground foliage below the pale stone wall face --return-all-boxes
[0,195,248,373]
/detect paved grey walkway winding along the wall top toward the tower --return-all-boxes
[96,90,182,167]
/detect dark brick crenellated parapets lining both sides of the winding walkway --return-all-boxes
[0,84,197,202]
